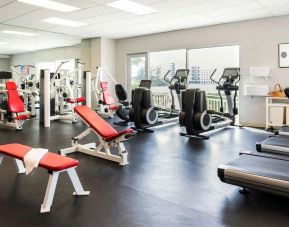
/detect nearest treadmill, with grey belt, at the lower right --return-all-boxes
[218,152,289,197]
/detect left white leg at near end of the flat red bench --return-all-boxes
[40,172,59,213]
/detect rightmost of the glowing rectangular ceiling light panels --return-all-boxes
[106,0,158,15]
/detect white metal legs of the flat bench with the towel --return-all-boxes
[0,154,90,213]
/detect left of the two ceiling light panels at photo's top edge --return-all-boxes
[17,0,80,12]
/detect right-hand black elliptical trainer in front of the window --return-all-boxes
[179,68,241,139]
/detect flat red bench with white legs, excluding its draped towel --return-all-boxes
[0,143,90,213]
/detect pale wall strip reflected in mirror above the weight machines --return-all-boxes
[11,46,81,65]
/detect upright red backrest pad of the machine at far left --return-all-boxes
[6,81,25,113]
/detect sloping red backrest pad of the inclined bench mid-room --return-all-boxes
[74,106,117,138]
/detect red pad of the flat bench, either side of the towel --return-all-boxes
[0,143,79,171]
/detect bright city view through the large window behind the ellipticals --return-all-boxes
[130,45,239,111]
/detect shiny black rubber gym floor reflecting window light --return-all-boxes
[0,120,289,227]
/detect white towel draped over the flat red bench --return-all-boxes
[24,148,48,175]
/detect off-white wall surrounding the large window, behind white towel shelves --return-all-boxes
[116,16,289,126]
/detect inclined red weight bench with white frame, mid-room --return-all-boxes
[59,106,133,165]
